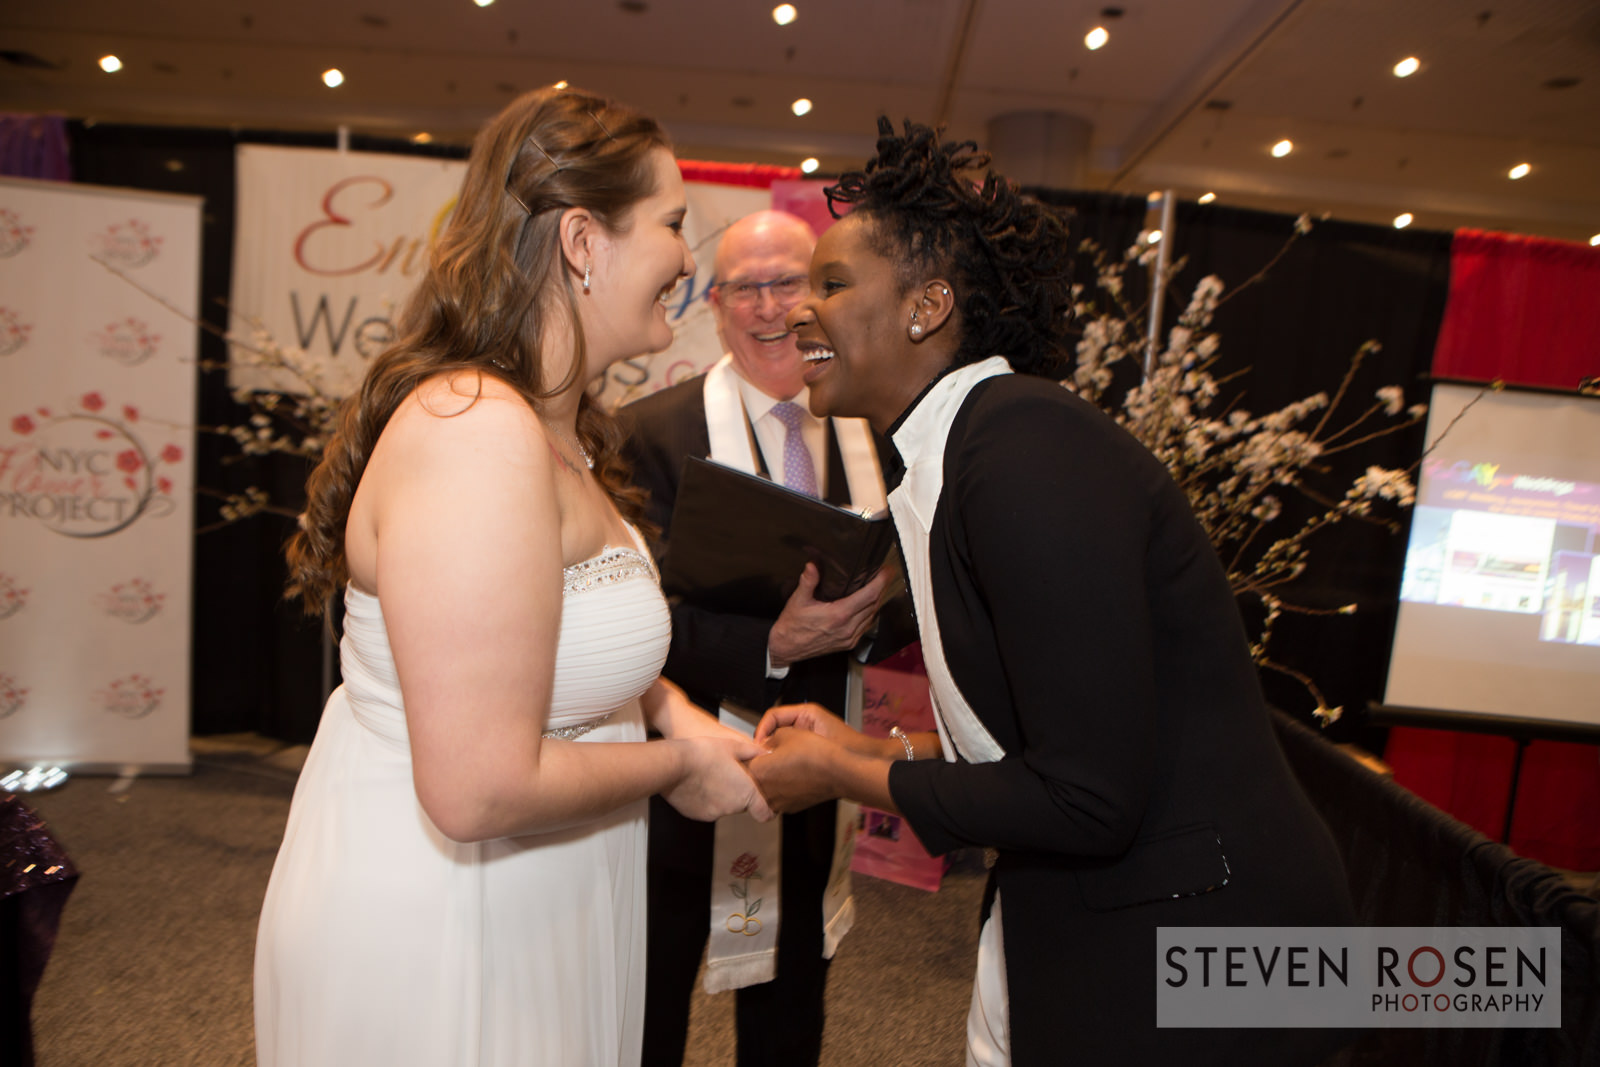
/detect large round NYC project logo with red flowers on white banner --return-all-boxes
[0,392,184,537]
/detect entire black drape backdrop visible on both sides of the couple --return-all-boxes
[53,123,1450,741]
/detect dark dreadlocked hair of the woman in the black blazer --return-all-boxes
[826,118,1072,378]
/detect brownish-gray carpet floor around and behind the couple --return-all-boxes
[27,736,982,1067]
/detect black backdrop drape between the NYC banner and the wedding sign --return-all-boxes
[69,123,464,742]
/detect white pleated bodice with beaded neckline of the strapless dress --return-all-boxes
[339,534,672,747]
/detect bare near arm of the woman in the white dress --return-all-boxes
[366,379,760,841]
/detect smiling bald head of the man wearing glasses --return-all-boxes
[710,211,816,400]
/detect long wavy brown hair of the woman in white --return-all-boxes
[288,90,672,614]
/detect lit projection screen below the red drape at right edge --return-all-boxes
[1384,384,1600,731]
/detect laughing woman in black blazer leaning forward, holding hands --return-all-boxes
[750,122,1352,1065]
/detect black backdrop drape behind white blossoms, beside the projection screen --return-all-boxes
[1166,203,1451,747]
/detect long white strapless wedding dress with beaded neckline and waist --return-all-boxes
[256,549,670,1067]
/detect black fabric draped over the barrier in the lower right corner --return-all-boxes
[1274,713,1600,1067]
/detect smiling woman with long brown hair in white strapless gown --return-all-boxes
[256,90,770,1067]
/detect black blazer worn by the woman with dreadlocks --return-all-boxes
[890,374,1354,1067]
